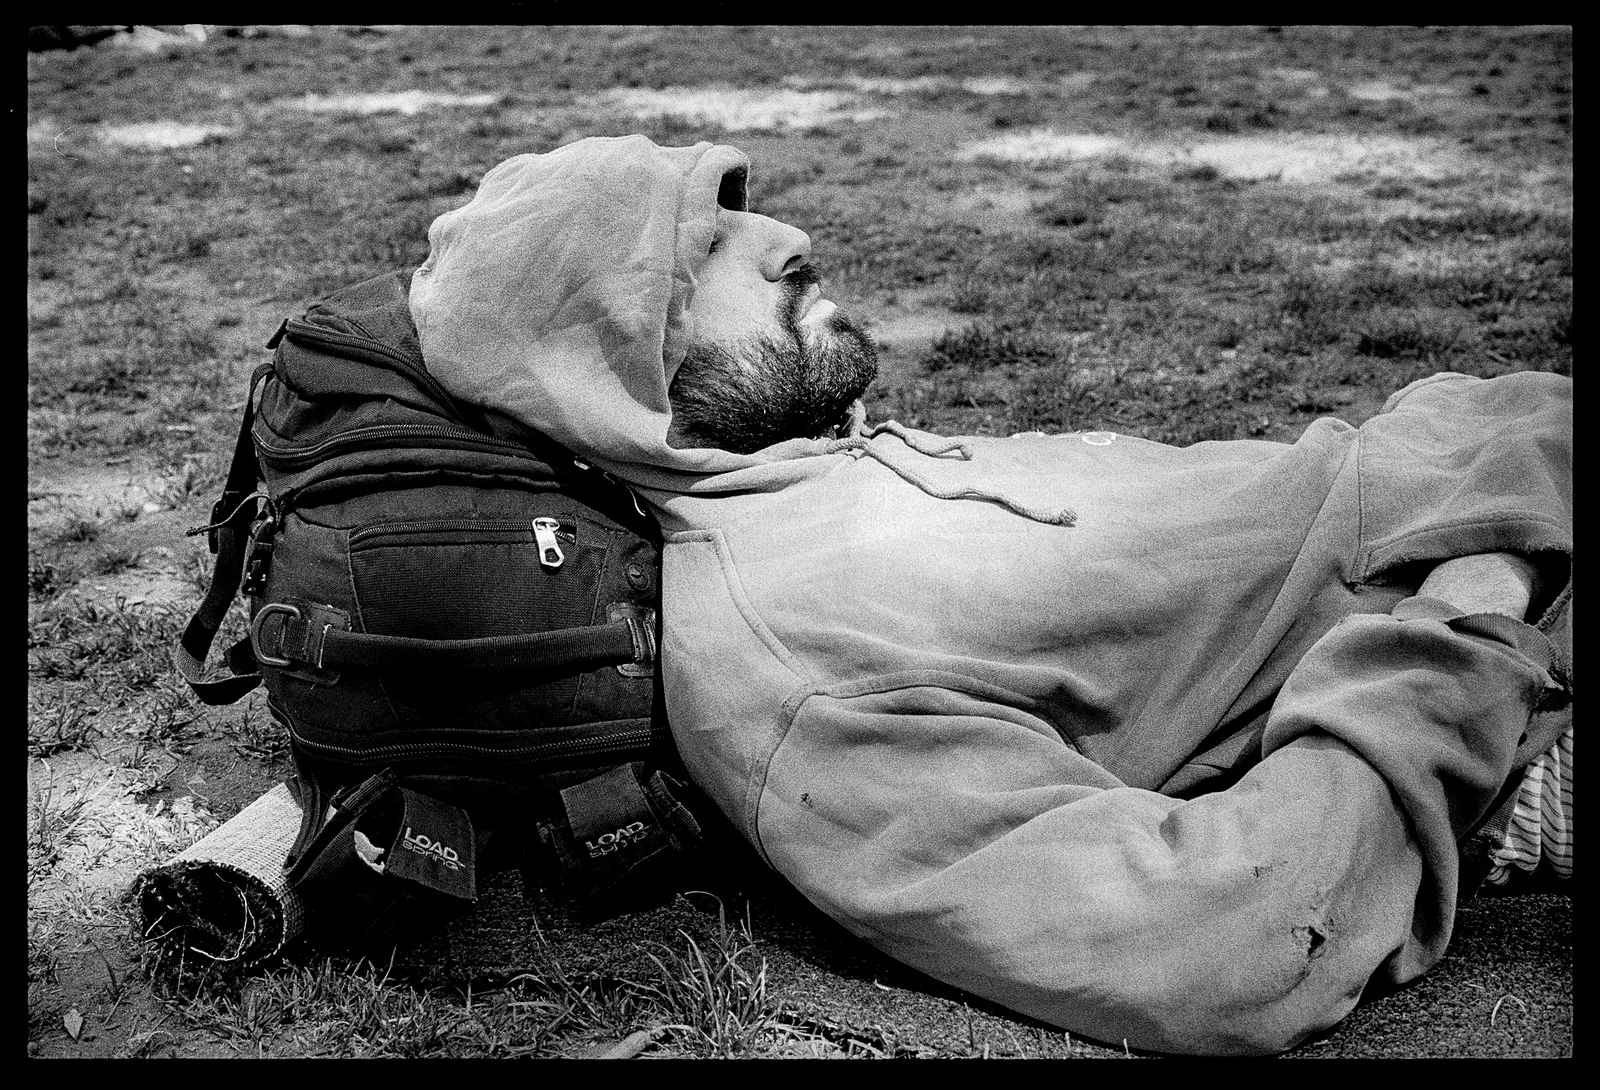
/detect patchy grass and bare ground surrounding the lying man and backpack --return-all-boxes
[27,27,1571,1056]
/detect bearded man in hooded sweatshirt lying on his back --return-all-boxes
[411,136,1571,1053]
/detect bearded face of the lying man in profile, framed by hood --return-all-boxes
[667,208,878,455]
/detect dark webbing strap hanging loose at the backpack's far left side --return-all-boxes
[173,363,272,704]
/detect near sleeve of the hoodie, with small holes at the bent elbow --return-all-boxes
[758,600,1549,1053]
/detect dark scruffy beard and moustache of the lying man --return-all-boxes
[667,296,878,455]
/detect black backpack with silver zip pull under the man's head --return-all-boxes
[174,274,699,941]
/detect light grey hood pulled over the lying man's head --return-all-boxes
[411,136,851,491]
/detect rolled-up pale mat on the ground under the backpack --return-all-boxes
[130,783,306,968]
